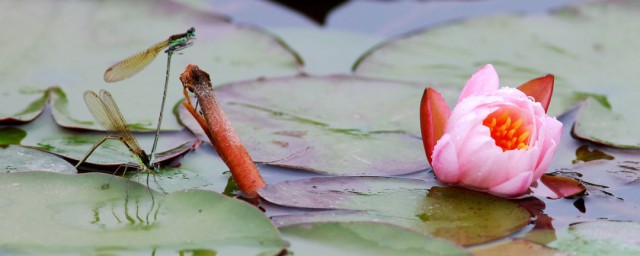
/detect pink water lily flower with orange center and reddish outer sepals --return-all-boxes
[420,64,562,197]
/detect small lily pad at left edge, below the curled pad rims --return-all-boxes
[0,145,77,174]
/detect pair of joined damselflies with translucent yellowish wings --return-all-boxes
[76,27,195,178]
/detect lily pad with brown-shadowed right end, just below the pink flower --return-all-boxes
[259,177,531,245]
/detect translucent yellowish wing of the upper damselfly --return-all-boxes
[104,40,169,83]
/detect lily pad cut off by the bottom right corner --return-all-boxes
[549,220,640,255]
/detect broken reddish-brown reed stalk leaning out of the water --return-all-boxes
[180,64,265,198]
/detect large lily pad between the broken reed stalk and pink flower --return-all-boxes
[179,75,440,175]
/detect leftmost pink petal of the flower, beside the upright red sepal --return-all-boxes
[431,134,460,183]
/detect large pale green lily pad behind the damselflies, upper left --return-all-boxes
[0,0,302,131]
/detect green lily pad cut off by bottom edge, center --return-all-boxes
[280,222,468,255]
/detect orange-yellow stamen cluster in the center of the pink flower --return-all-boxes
[482,109,531,151]
